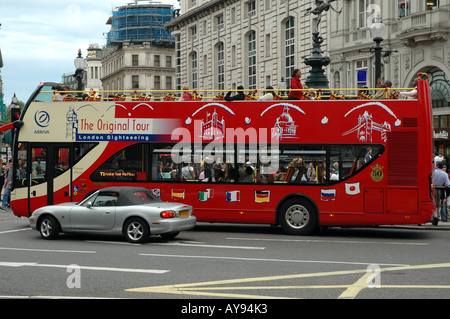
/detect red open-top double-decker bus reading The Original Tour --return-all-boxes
[6,80,434,234]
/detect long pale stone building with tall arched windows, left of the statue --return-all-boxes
[166,0,326,90]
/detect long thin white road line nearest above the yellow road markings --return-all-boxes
[139,254,409,267]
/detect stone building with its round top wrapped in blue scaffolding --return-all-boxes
[100,0,175,99]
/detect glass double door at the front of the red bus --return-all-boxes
[26,143,73,214]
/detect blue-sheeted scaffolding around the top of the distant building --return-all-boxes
[106,0,175,46]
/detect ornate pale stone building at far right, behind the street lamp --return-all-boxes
[328,0,450,157]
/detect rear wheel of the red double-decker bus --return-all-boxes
[278,198,317,235]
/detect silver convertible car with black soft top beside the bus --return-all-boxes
[29,187,197,243]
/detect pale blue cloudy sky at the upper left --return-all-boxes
[0,0,179,105]
